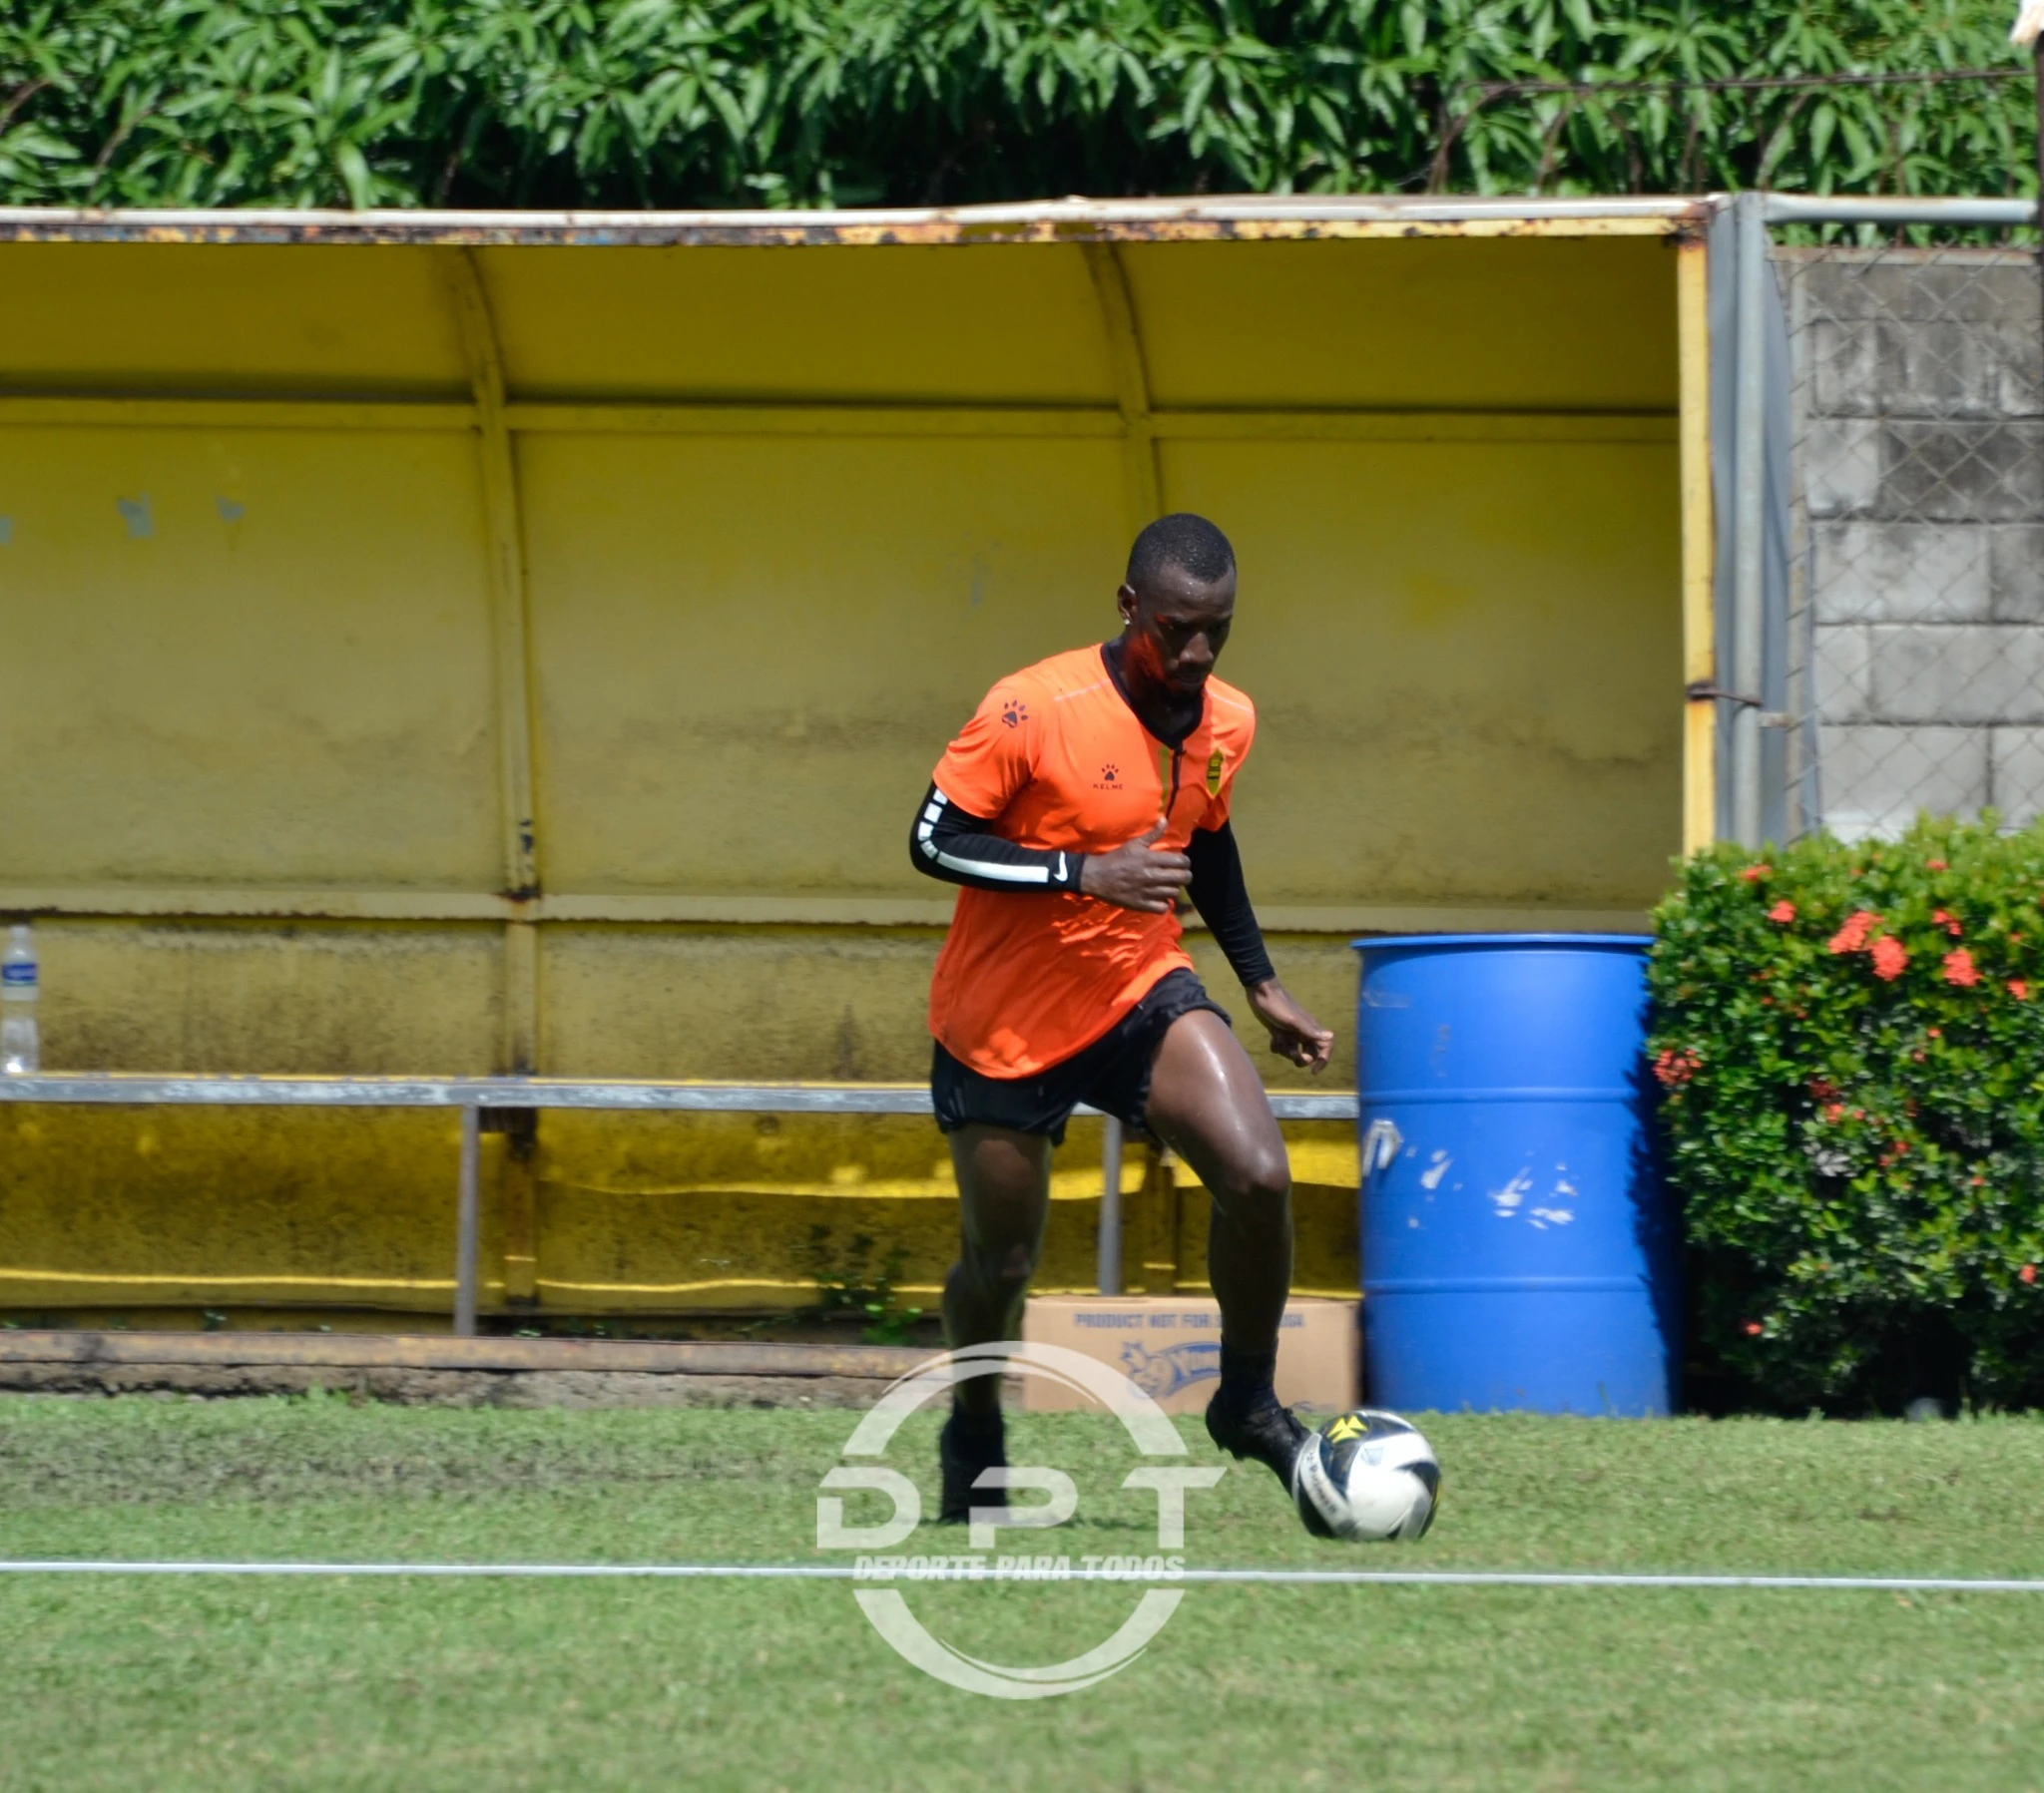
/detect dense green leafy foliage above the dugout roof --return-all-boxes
[0,0,2034,207]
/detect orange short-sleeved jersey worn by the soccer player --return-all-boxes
[930,646,1258,1078]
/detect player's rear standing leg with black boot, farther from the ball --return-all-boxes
[938,1126,1051,1521]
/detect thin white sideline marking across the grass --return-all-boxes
[0,1558,2044,1594]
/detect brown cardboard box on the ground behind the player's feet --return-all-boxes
[1022,1294,1361,1415]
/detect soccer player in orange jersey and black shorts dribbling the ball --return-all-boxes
[909,513,1334,1519]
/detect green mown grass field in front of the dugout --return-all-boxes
[0,1396,2044,1793]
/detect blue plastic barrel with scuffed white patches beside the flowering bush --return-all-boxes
[1355,934,1680,1415]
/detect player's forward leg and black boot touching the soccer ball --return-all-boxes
[1147,1010,1306,1480]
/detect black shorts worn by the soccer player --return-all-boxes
[930,965,1229,1144]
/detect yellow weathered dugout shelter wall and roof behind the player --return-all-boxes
[0,203,1709,1312]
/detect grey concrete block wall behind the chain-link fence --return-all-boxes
[1777,249,2044,838]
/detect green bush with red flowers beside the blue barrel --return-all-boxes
[1650,820,2044,1407]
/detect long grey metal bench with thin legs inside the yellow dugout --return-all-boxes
[0,1072,1357,1339]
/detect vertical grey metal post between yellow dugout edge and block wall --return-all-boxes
[1730,193,1769,846]
